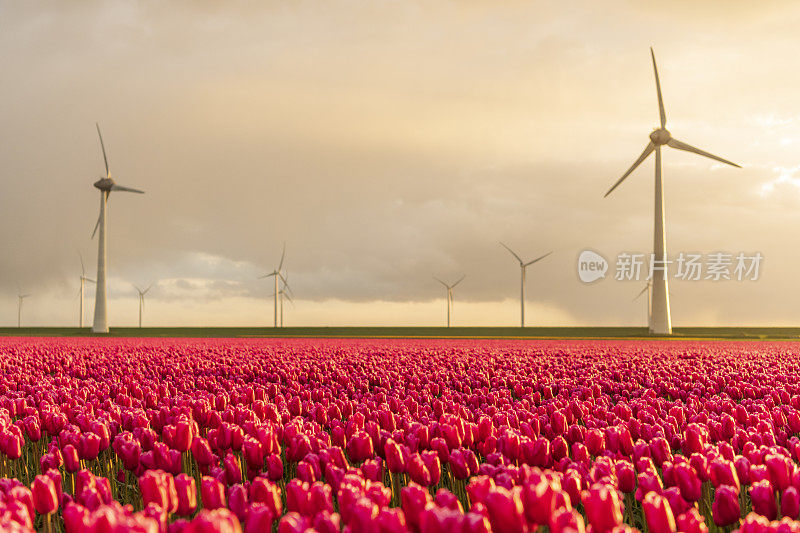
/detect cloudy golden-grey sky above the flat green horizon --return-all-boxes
[0,0,800,326]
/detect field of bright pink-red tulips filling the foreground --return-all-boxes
[0,337,800,533]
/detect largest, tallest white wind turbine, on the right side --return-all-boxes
[605,47,741,335]
